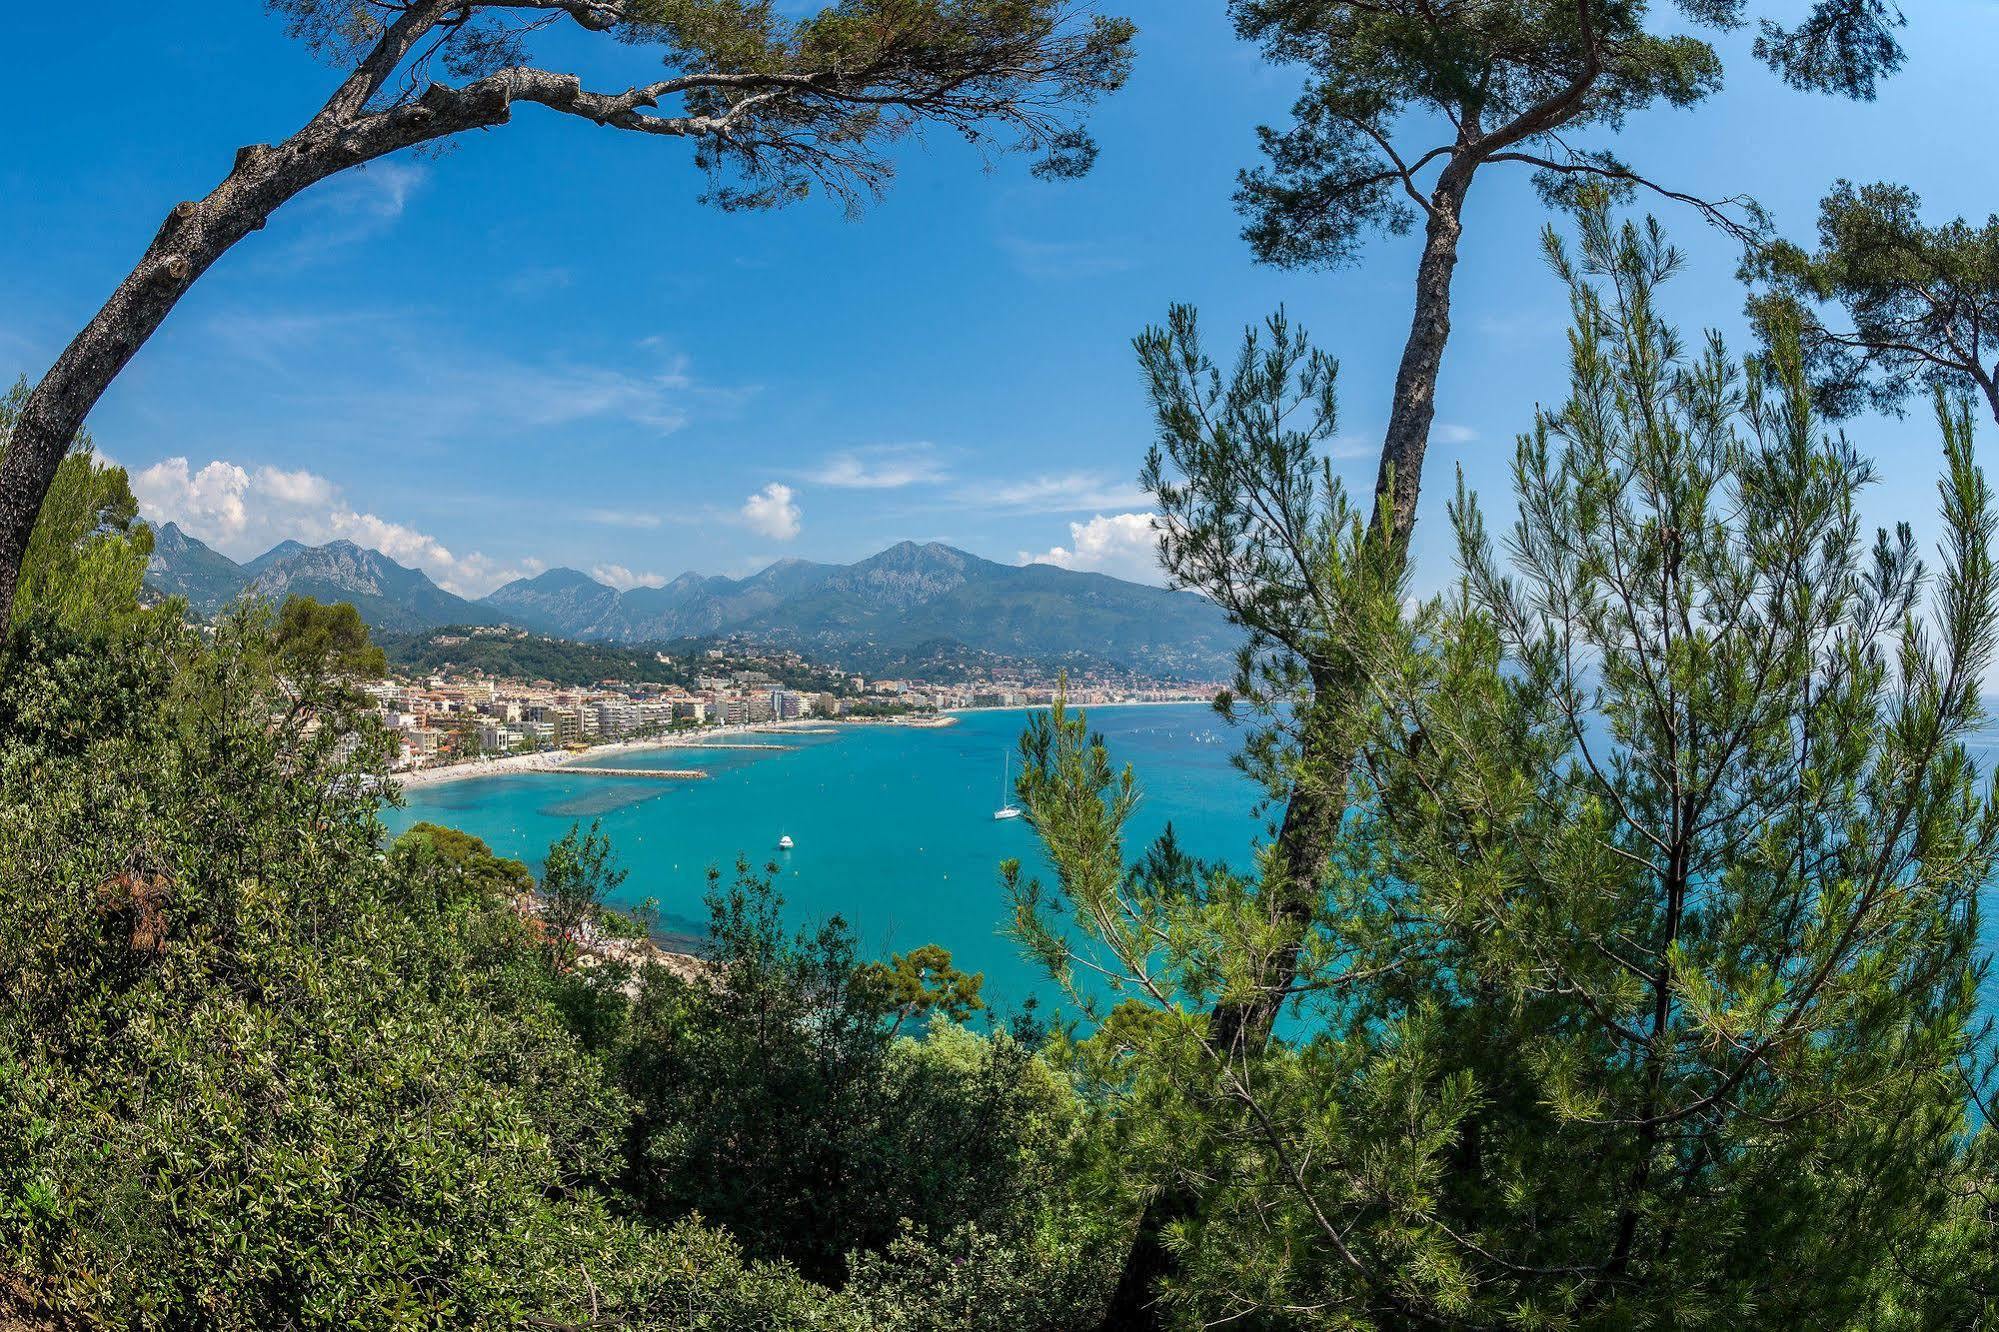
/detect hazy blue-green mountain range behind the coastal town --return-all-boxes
[148,522,1239,678]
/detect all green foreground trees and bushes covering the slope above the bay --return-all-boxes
[0,216,1999,1332]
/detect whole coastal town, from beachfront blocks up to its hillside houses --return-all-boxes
[366,632,1217,780]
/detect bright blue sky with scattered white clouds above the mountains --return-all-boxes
[0,0,1999,596]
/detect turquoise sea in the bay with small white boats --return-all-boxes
[382,704,1263,1012]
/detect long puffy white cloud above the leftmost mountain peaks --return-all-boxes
[132,458,542,596]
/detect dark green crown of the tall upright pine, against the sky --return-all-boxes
[1231,0,1901,266]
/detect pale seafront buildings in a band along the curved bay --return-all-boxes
[366,652,1213,770]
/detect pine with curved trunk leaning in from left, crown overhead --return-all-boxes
[0,0,1133,618]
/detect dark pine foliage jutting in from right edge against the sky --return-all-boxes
[1747,180,1999,420]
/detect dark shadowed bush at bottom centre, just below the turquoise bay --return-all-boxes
[618,866,1103,1282]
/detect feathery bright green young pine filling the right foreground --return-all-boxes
[1007,210,1999,1328]
